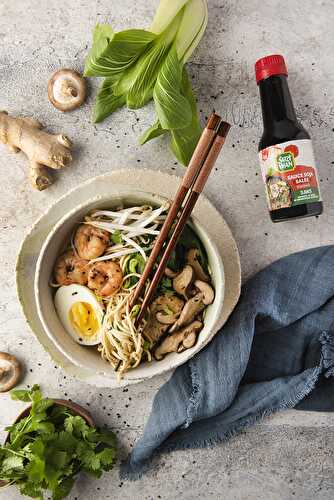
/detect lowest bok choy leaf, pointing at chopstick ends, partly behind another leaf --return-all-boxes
[171,68,202,165]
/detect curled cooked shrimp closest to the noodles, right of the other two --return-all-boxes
[88,261,123,297]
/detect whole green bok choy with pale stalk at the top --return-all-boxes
[85,0,208,165]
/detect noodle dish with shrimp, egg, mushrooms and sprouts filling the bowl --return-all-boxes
[50,203,215,377]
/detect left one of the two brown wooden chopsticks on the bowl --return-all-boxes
[131,113,221,307]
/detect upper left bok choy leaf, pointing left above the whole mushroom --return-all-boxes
[85,25,157,79]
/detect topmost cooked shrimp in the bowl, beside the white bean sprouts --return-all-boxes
[74,224,110,260]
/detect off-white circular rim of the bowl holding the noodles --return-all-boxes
[34,189,225,381]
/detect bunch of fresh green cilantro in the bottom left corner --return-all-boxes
[0,385,116,500]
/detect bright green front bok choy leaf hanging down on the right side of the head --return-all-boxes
[153,47,192,130]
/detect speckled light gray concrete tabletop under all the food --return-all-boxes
[0,0,334,500]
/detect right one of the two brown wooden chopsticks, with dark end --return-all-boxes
[136,121,231,324]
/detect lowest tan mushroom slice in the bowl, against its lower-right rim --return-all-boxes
[154,321,203,360]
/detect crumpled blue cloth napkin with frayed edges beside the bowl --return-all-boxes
[121,246,334,479]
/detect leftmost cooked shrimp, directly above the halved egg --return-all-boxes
[54,250,89,285]
